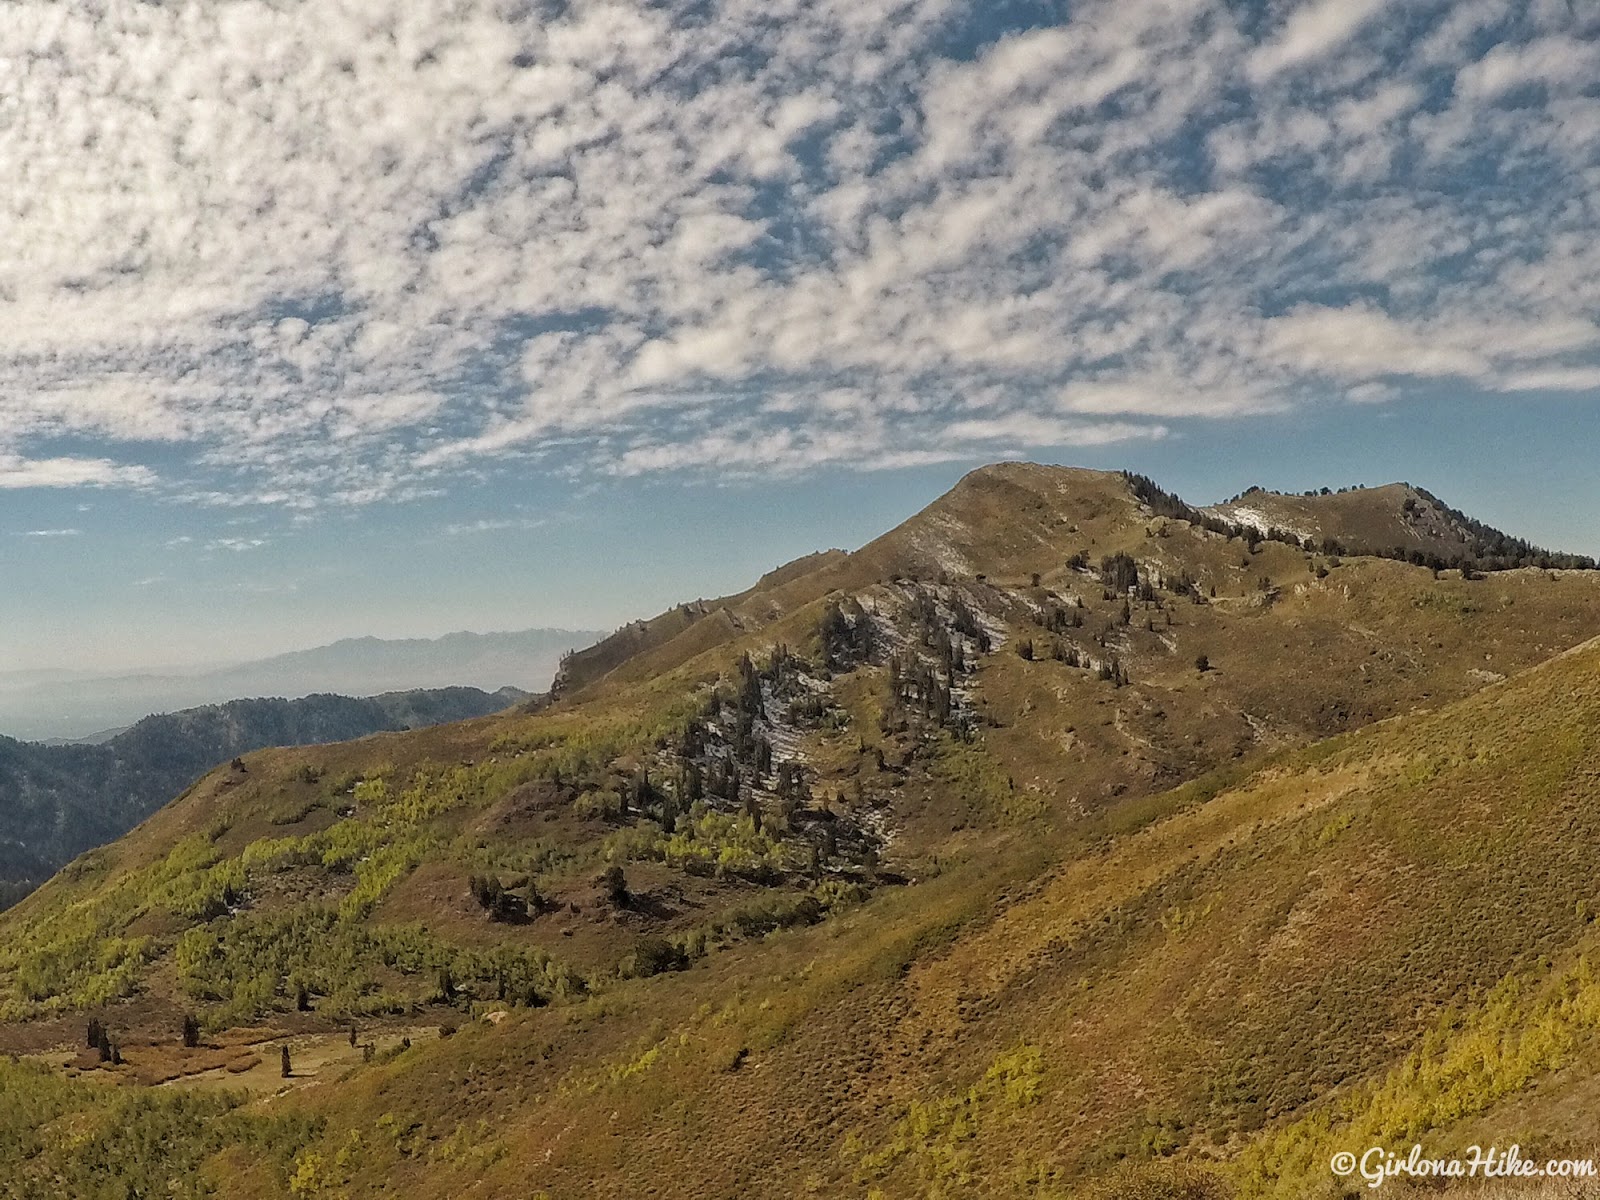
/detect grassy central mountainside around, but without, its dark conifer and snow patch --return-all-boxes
[15,464,1600,1043]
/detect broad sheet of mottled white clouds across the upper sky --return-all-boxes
[0,0,1600,507]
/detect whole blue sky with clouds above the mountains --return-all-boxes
[0,0,1600,670]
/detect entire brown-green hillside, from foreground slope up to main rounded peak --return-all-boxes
[0,464,1600,1200]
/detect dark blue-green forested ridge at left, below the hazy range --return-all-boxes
[0,688,528,902]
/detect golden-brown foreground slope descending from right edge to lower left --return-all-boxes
[212,633,1600,1197]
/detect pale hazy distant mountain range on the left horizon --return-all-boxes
[0,629,602,741]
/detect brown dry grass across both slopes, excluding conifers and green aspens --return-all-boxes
[0,467,1600,1200]
